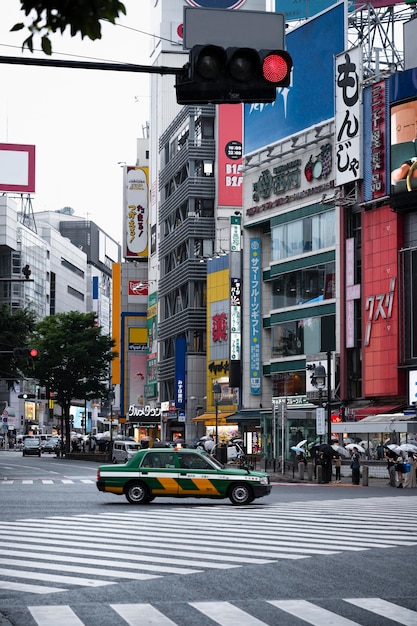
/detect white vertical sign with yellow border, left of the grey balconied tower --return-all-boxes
[124,166,149,259]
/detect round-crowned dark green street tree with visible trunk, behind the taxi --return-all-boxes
[23,311,117,451]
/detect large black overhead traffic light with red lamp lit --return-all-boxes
[175,45,293,104]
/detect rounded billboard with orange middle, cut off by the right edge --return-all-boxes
[389,68,417,211]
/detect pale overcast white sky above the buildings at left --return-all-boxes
[0,0,152,243]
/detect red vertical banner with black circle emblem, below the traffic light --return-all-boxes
[217,104,243,207]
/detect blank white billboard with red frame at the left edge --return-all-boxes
[0,143,35,193]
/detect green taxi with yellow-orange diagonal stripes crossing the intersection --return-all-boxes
[97,448,271,505]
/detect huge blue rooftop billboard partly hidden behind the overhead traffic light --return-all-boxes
[244,3,345,154]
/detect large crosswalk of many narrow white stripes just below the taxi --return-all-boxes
[0,496,417,598]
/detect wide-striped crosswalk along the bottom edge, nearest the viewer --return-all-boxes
[22,598,417,626]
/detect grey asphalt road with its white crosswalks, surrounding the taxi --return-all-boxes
[0,451,417,626]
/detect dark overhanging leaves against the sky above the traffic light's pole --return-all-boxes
[11,0,126,55]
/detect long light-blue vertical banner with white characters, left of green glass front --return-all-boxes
[249,237,262,395]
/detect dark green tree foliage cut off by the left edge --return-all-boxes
[0,304,36,389]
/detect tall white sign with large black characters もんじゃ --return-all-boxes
[335,47,363,186]
